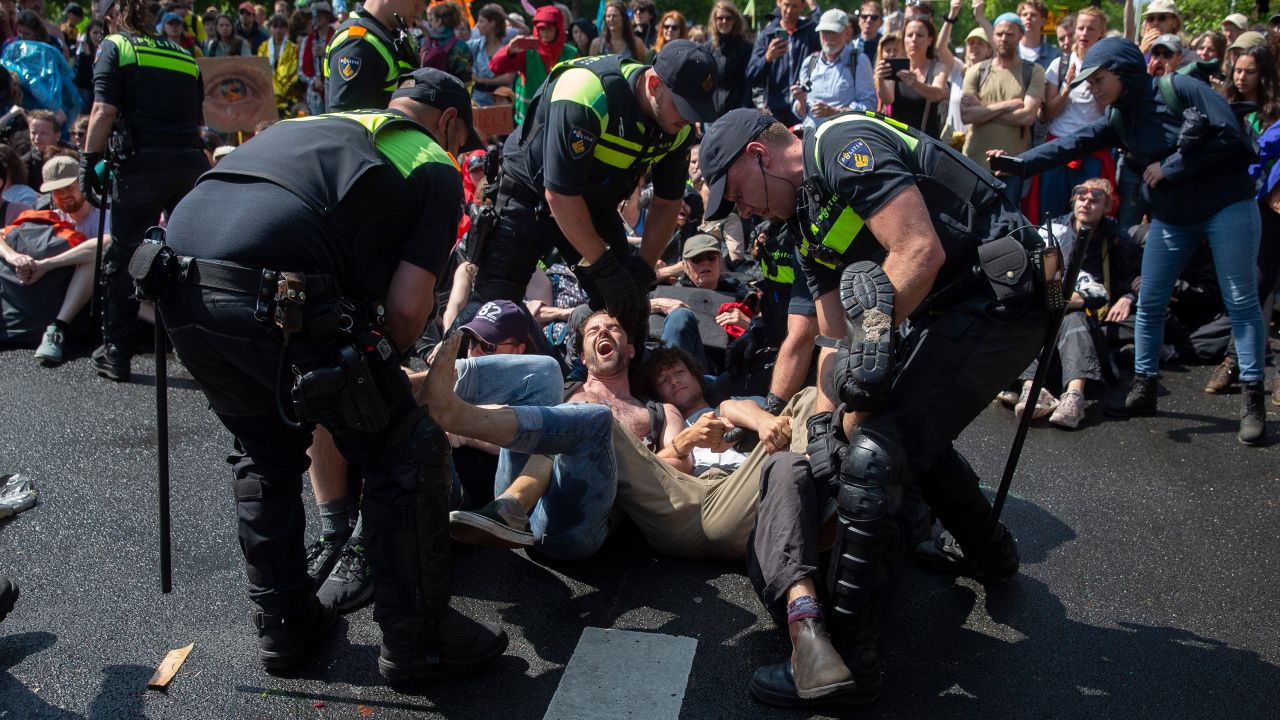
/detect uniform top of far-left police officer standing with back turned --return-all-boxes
[93,33,205,147]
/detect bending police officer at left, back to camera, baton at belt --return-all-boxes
[153,69,507,684]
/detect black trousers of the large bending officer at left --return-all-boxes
[160,286,451,625]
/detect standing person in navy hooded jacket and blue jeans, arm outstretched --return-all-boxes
[992,39,1266,445]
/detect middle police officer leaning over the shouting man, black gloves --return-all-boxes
[473,40,716,328]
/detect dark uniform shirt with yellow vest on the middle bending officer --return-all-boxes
[503,65,692,211]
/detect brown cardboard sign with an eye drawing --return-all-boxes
[196,56,279,135]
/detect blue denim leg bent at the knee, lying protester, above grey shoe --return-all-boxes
[494,404,618,560]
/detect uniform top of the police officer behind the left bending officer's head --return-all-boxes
[325,14,417,113]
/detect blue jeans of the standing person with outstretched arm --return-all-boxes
[1134,199,1266,382]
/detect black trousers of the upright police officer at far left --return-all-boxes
[102,146,208,355]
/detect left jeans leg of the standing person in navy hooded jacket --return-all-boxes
[1133,219,1203,378]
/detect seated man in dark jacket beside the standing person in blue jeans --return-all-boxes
[998,178,1138,428]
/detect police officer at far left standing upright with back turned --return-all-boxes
[81,0,209,382]
